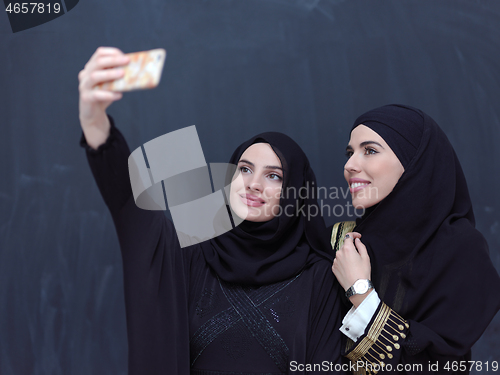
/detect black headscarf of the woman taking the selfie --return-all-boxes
[202,132,332,285]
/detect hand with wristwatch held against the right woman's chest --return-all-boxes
[332,232,371,306]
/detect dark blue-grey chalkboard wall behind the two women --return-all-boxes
[0,0,500,375]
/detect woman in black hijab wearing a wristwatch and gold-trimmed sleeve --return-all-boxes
[332,105,500,374]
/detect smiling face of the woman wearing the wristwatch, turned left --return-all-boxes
[344,125,404,209]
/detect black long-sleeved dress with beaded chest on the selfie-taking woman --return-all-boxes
[81,121,348,375]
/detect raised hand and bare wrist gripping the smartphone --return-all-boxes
[78,47,129,149]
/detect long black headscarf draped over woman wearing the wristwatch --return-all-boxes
[353,105,500,355]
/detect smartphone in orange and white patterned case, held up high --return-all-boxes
[96,48,167,91]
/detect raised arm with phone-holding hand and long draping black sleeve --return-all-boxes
[79,48,195,374]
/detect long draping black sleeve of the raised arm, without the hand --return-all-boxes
[80,117,191,375]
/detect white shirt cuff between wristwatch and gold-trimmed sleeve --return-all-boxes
[339,289,380,342]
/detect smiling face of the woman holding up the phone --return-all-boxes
[229,143,283,222]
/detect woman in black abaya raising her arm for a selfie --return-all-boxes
[79,48,341,375]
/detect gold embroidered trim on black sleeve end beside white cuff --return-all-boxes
[346,302,410,374]
